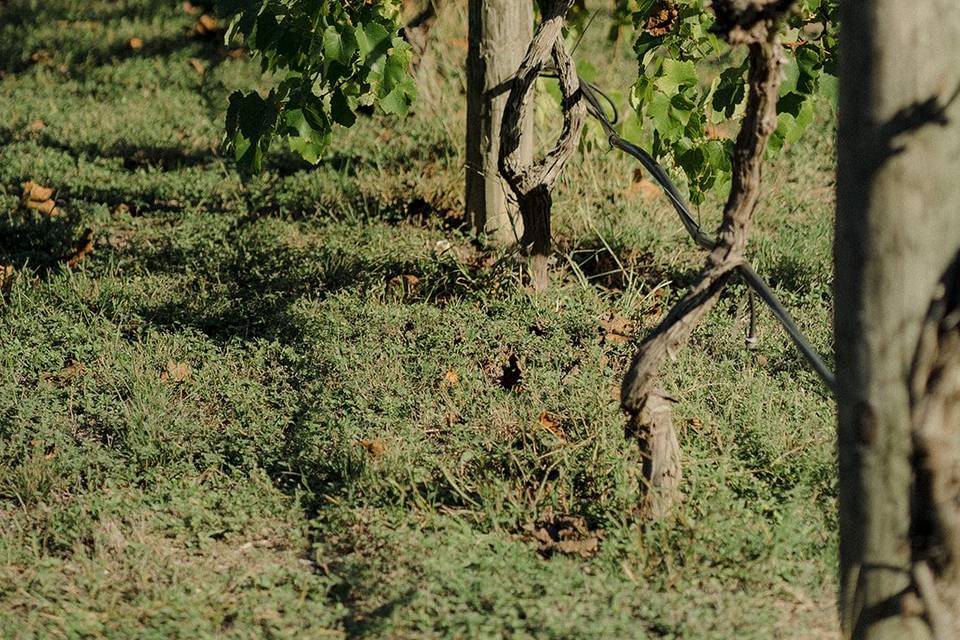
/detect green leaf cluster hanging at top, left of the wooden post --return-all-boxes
[220,0,414,170]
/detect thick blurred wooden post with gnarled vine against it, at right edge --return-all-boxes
[835,0,960,640]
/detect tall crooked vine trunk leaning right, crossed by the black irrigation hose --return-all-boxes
[621,1,783,517]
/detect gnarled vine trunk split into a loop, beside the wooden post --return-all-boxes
[499,0,587,291]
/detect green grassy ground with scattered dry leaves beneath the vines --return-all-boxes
[0,0,836,639]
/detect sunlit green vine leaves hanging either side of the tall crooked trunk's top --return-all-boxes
[616,0,838,204]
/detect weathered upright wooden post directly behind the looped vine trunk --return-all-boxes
[466,0,533,244]
